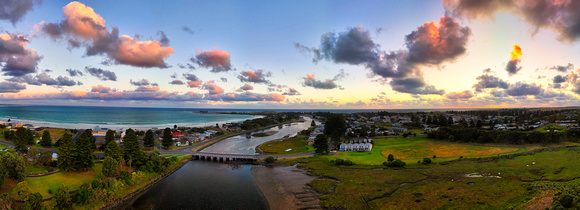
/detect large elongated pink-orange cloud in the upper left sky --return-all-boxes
[35,1,173,68]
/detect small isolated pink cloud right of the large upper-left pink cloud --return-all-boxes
[190,48,232,73]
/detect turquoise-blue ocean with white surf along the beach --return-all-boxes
[0,105,260,129]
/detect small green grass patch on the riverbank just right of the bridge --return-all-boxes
[260,135,314,155]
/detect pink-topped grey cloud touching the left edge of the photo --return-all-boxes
[0,34,42,77]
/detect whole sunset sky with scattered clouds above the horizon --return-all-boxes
[0,0,580,109]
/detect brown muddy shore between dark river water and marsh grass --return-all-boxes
[250,166,321,209]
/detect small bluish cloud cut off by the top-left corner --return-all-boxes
[0,0,42,25]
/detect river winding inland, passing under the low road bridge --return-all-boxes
[117,118,311,209]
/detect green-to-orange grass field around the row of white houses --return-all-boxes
[328,137,526,165]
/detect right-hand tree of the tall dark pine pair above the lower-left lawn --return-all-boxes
[75,130,95,171]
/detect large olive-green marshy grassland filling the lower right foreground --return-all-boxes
[281,148,580,209]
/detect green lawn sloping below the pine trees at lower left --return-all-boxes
[24,164,103,198]
